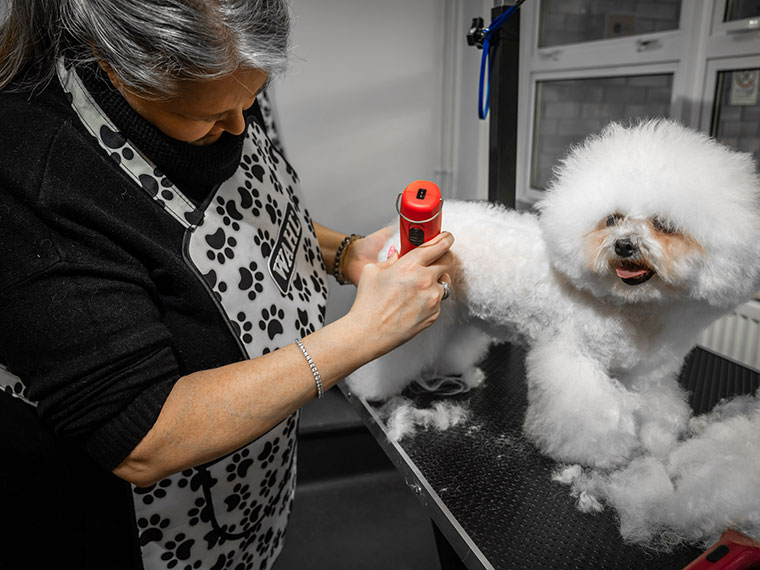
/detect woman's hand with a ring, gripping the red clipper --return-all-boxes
[346,232,454,357]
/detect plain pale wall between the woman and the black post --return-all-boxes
[274,0,485,320]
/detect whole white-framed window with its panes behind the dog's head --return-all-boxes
[517,0,760,203]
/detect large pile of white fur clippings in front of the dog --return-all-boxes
[554,388,760,550]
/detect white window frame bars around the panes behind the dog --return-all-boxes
[516,0,760,204]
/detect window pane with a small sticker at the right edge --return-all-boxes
[710,69,760,161]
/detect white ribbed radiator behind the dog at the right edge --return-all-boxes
[697,301,760,370]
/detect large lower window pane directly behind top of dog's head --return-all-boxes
[530,74,673,189]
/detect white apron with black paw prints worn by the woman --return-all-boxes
[48,62,327,570]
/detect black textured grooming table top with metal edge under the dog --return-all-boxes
[341,344,760,570]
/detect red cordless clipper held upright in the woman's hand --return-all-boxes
[396,180,443,255]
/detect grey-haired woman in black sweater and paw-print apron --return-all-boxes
[0,0,453,570]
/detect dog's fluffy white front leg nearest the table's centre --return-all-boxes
[524,335,639,468]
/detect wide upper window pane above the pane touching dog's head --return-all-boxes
[538,0,681,47]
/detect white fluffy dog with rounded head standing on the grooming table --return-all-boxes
[348,120,760,467]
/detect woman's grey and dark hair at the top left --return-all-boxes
[0,0,290,98]
